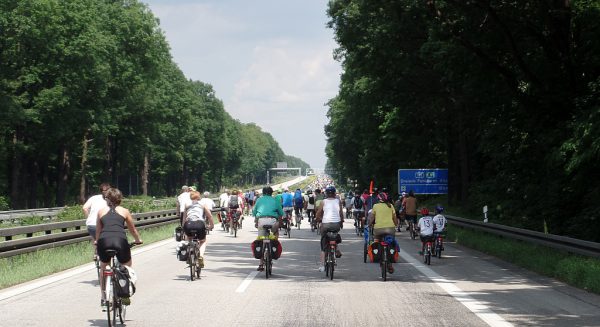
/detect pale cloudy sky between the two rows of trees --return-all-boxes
[142,0,341,168]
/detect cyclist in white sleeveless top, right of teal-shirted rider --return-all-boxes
[316,186,344,272]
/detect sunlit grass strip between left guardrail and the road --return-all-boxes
[0,223,179,289]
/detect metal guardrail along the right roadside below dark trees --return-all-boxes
[446,216,600,258]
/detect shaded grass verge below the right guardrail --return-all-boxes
[448,226,600,294]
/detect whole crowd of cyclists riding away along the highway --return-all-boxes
[83,183,447,300]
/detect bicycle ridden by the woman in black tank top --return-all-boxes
[102,243,138,327]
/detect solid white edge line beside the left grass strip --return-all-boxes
[0,238,173,301]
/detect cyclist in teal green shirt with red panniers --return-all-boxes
[252,186,283,271]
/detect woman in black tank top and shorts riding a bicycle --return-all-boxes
[94,188,142,306]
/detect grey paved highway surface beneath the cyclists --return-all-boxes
[0,217,600,327]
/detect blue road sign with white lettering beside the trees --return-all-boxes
[398,168,448,194]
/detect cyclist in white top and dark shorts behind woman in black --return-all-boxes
[183,191,214,268]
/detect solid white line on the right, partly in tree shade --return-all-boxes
[400,251,513,327]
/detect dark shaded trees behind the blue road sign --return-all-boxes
[326,0,600,241]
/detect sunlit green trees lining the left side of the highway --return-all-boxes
[0,0,308,209]
